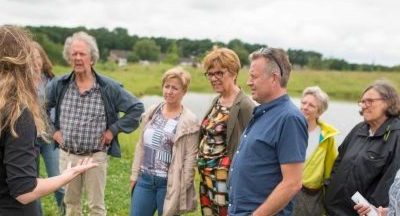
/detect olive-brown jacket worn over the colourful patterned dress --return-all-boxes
[200,90,255,160]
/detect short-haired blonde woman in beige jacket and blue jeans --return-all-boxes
[130,68,199,216]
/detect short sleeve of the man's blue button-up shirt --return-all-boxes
[276,115,308,164]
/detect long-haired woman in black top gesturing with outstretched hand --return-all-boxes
[0,26,97,216]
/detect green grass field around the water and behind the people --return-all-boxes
[41,64,400,216]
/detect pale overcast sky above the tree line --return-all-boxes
[0,0,400,66]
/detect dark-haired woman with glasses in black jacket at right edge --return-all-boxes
[325,81,400,215]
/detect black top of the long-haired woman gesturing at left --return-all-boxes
[0,110,39,216]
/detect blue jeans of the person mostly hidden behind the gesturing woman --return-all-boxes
[36,138,64,211]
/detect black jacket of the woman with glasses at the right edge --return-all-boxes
[325,117,400,216]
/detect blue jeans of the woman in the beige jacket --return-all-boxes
[130,173,167,216]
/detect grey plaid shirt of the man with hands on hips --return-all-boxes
[60,80,107,153]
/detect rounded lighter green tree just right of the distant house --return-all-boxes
[133,38,161,61]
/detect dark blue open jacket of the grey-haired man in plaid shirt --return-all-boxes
[46,70,144,157]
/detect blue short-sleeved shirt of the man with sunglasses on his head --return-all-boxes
[229,94,308,216]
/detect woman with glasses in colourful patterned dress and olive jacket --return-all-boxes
[198,48,254,215]
